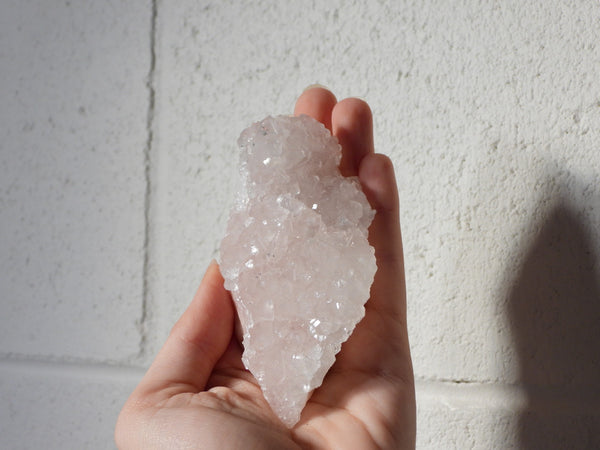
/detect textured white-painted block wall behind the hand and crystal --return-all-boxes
[0,0,600,449]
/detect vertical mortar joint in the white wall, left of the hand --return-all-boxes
[137,0,158,360]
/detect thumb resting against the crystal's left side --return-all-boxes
[138,263,234,395]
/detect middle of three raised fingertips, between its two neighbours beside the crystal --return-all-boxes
[331,98,374,176]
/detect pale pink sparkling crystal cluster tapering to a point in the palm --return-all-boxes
[221,116,376,427]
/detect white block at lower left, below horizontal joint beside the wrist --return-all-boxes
[0,361,141,450]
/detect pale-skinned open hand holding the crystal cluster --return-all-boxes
[115,87,416,450]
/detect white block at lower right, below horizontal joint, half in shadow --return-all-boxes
[417,382,600,450]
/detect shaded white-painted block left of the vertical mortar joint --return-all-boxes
[0,0,151,361]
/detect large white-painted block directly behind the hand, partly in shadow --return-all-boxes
[149,1,600,386]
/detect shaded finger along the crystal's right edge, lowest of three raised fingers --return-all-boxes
[358,153,406,324]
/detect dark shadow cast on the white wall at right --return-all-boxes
[508,189,600,449]
